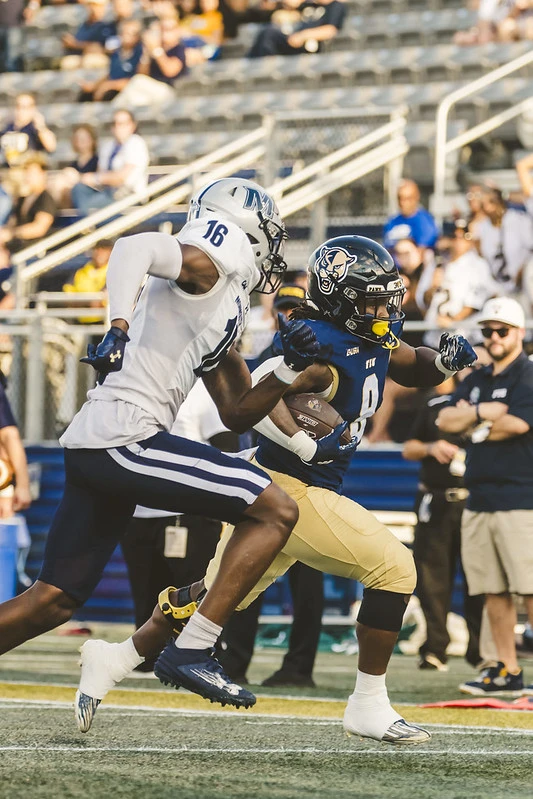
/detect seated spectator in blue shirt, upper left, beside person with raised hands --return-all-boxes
[79,19,143,102]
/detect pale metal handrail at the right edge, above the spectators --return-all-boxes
[433,49,533,222]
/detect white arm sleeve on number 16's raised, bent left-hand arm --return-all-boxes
[107,233,182,324]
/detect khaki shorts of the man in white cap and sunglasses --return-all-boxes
[461,510,533,596]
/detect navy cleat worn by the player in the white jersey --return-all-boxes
[154,641,256,707]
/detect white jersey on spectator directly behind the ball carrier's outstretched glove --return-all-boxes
[424,250,498,349]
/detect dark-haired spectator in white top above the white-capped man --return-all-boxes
[476,188,533,294]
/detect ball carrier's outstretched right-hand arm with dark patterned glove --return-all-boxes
[389,333,477,388]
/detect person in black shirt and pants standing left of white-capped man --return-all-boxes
[403,368,485,671]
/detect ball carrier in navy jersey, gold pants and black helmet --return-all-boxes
[77,236,476,744]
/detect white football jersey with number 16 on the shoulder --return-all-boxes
[60,217,260,449]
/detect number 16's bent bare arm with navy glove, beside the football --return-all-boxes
[202,322,319,433]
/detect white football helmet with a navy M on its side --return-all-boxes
[187,178,287,294]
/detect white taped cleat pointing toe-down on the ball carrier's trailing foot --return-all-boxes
[74,641,120,732]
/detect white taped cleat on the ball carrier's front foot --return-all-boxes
[343,697,431,744]
